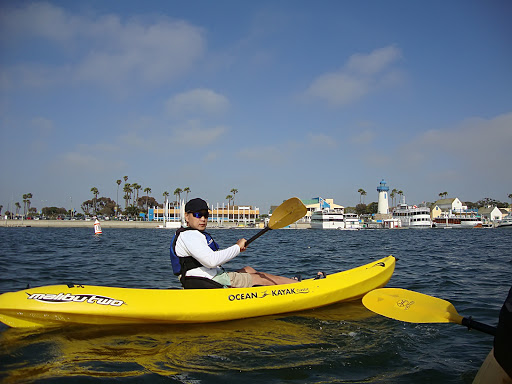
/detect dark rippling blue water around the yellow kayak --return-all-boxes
[0,228,512,383]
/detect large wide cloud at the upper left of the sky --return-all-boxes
[0,3,205,91]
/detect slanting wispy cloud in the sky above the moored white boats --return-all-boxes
[305,46,402,106]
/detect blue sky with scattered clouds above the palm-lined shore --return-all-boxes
[0,0,512,213]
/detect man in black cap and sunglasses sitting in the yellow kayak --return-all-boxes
[171,198,297,288]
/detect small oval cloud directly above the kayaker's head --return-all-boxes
[165,89,230,116]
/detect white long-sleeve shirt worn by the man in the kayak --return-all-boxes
[175,230,240,279]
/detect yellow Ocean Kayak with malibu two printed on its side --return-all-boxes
[0,256,396,328]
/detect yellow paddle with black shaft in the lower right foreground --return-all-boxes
[363,288,496,336]
